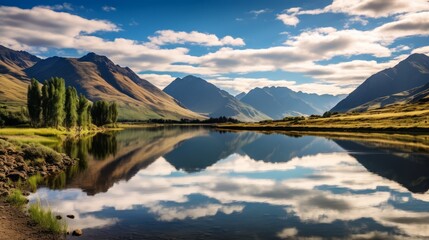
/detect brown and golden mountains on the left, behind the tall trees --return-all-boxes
[0,47,204,120]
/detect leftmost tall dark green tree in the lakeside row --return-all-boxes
[27,78,42,127]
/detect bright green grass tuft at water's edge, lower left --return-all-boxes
[28,202,67,233]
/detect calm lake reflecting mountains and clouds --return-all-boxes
[30,127,429,239]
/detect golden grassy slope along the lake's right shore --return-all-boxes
[219,101,429,131]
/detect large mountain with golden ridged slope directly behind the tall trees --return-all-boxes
[20,53,202,120]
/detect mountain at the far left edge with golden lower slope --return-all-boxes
[0,45,40,108]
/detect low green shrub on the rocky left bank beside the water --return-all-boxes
[21,143,62,163]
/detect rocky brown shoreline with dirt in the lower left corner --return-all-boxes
[0,139,78,240]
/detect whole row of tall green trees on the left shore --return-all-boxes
[27,77,118,129]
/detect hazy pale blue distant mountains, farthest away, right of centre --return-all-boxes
[241,87,343,119]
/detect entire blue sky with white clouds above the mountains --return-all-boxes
[0,0,429,94]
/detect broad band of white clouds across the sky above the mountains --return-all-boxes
[0,4,429,93]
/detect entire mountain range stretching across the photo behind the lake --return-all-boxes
[0,45,429,121]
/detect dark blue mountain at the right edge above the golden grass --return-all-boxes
[331,54,429,112]
